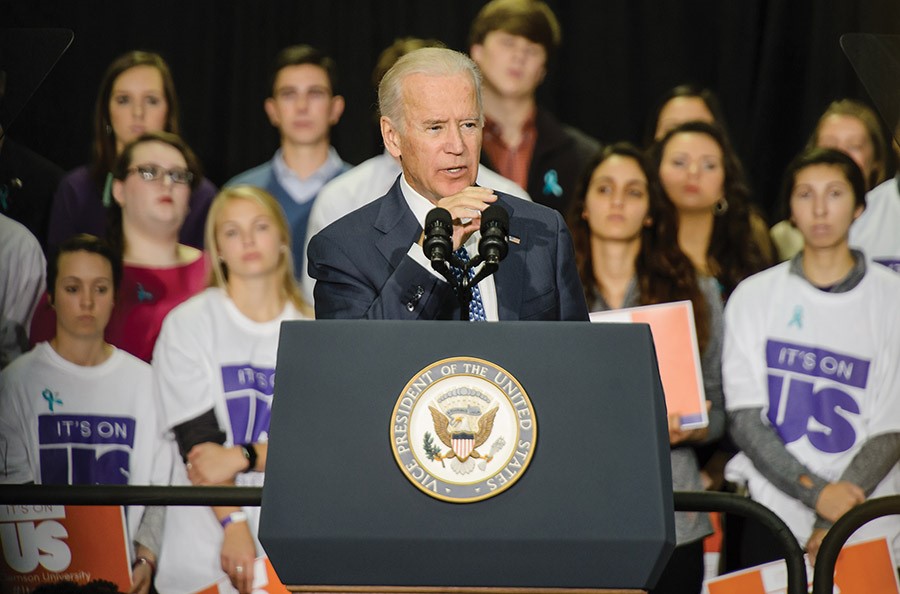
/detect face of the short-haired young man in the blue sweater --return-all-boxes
[265,64,344,146]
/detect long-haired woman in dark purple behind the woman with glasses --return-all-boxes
[47,51,216,248]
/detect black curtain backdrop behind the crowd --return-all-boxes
[0,0,900,217]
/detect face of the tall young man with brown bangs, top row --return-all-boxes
[469,31,547,98]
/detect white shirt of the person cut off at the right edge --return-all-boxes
[850,173,900,272]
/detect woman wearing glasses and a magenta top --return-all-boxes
[31,132,207,362]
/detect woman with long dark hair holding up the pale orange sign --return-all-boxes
[568,143,725,594]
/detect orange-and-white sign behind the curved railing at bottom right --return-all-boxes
[705,538,900,594]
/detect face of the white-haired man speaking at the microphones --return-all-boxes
[381,74,481,203]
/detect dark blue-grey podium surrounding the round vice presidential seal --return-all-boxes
[259,320,675,594]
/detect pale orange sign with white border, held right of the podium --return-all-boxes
[591,301,709,429]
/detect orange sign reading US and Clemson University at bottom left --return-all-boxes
[0,505,131,594]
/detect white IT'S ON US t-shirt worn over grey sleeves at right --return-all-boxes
[722,262,900,549]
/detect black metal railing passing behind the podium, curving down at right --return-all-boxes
[0,485,808,594]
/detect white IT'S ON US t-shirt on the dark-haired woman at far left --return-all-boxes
[0,342,165,534]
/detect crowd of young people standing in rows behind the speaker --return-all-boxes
[0,0,900,594]
